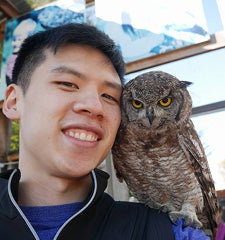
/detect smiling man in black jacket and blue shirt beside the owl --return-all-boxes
[0,24,211,240]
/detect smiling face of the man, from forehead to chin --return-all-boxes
[15,45,121,177]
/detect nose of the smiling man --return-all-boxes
[73,90,104,118]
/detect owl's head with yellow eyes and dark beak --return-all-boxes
[121,71,192,130]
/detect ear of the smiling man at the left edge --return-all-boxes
[2,84,22,120]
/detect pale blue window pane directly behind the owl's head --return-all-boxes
[126,48,225,107]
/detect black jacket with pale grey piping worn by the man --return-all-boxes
[0,170,174,240]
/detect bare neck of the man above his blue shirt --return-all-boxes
[18,172,92,206]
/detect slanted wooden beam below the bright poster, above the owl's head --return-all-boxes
[126,31,225,73]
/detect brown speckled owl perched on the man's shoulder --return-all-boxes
[112,71,218,236]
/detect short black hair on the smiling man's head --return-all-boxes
[12,23,125,93]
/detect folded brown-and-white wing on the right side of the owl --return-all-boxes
[178,121,218,235]
